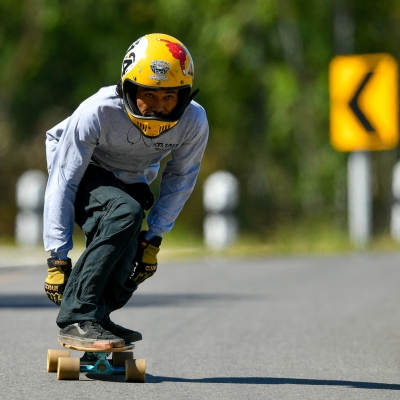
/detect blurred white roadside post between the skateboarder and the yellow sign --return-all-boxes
[203,171,239,250]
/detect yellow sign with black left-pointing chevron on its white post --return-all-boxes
[329,53,399,247]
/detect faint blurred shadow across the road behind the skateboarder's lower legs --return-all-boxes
[0,293,255,308]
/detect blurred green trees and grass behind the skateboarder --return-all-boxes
[0,0,400,254]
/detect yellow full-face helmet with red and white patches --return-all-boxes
[121,33,198,138]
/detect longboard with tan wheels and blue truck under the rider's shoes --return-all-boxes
[47,343,146,383]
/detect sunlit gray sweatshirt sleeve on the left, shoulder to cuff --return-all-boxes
[43,108,100,256]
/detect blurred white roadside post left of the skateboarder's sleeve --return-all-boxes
[15,170,47,246]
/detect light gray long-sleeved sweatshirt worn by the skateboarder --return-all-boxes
[43,86,208,258]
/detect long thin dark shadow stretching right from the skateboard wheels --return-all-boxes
[146,374,400,390]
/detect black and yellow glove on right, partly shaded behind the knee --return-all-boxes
[130,231,162,285]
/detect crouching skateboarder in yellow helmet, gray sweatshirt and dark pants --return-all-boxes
[44,34,208,347]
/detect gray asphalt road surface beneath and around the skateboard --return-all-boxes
[0,254,400,400]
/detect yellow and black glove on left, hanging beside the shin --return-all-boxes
[44,257,72,306]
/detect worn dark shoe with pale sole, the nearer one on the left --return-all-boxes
[58,321,125,348]
